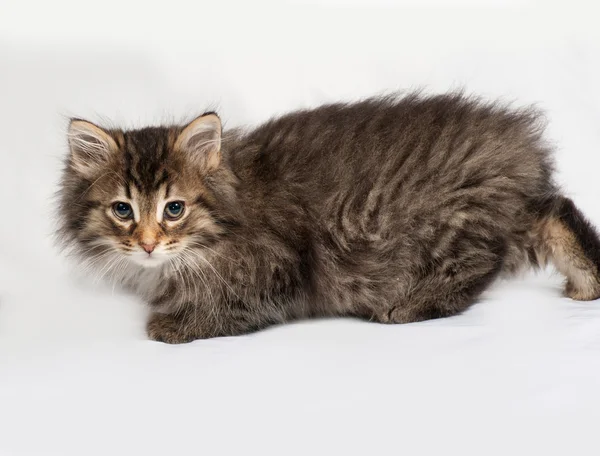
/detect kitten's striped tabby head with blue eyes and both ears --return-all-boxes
[60,113,234,267]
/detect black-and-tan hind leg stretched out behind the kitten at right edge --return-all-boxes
[534,196,600,301]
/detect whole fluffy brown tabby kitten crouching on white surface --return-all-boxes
[59,94,600,343]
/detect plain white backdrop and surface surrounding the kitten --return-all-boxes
[0,0,600,456]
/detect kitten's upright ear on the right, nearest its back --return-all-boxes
[175,113,221,169]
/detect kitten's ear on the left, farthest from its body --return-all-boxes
[68,119,118,178]
